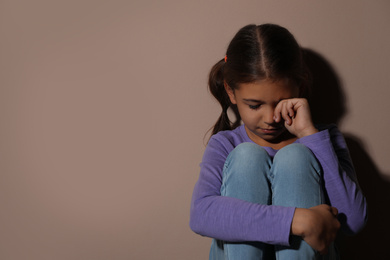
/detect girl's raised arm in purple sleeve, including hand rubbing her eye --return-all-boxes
[274,98,367,234]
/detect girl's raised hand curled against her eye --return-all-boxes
[274,98,318,138]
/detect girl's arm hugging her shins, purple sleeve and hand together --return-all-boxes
[190,132,340,253]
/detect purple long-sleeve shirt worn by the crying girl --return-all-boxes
[190,125,367,245]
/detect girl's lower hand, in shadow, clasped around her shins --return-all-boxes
[291,204,340,254]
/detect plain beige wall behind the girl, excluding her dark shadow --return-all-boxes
[0,0,390,260]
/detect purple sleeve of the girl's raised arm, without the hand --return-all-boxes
[299,126,367,234]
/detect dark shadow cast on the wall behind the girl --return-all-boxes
[304,49,390,260]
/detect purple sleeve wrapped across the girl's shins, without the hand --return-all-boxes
[190,135,295,245]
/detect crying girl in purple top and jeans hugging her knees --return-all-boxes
[190,24,367,260]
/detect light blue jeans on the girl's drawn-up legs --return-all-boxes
[210,143,338,260]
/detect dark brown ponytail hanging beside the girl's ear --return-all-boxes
[209,59,241,135]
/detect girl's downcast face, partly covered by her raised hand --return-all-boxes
[225,80,299,147]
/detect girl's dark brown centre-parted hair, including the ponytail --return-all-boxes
[209,24,309,134]
